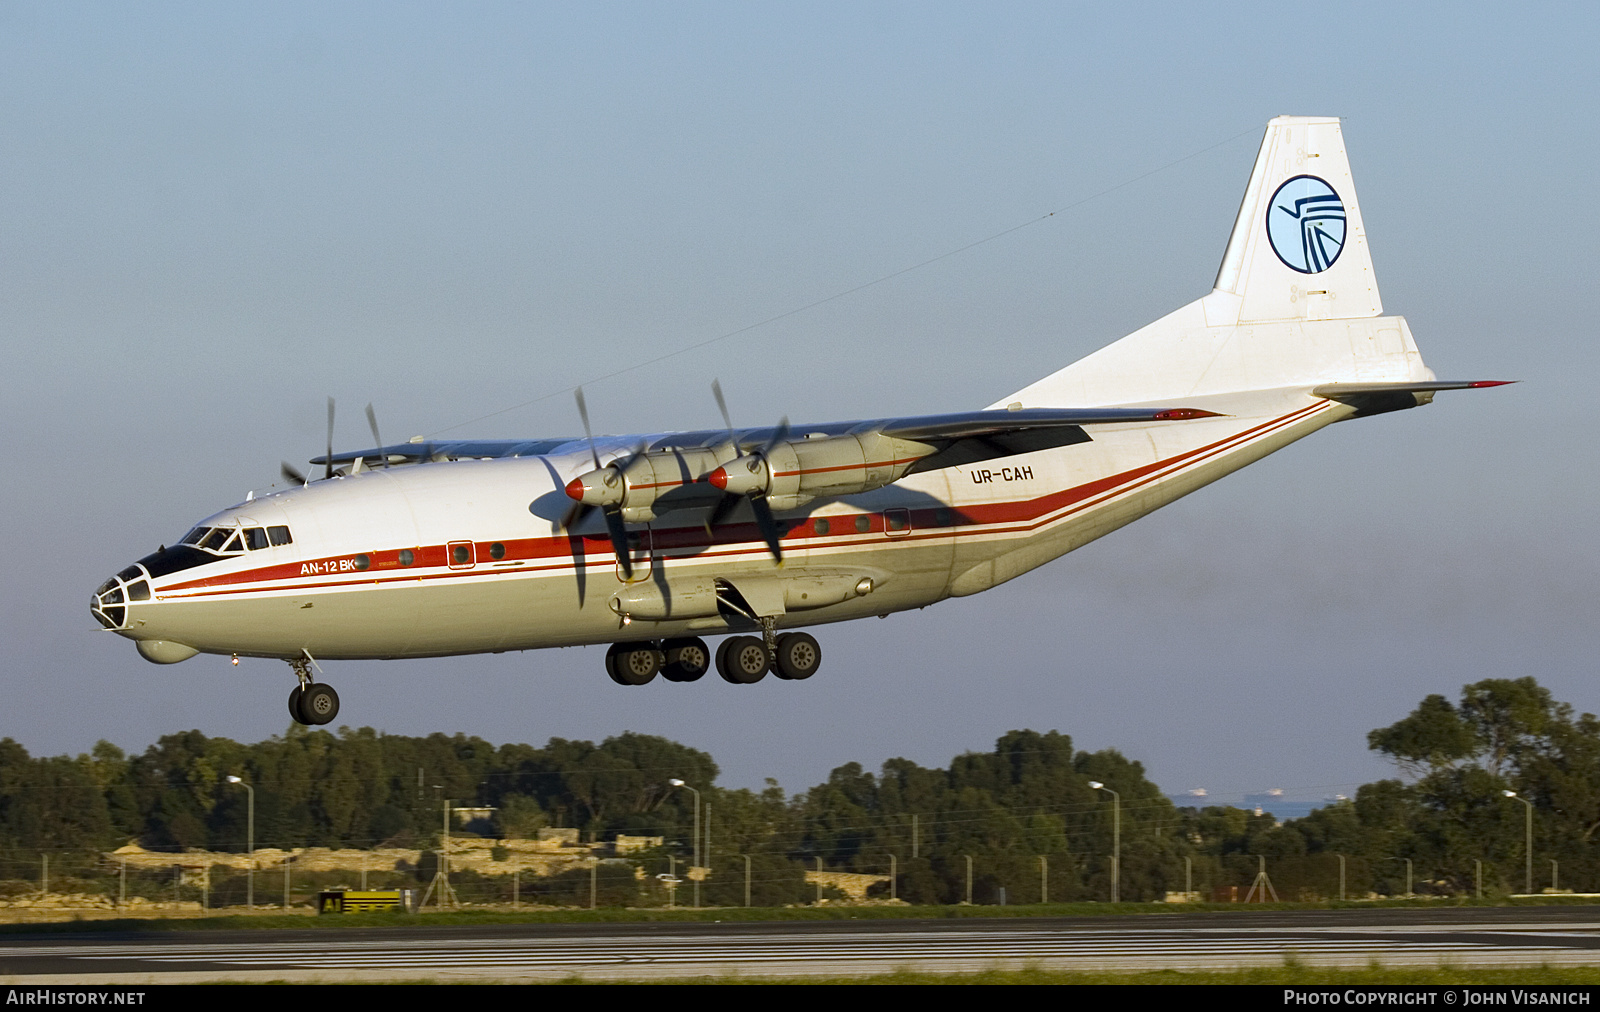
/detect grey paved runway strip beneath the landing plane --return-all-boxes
[0,908,1600,985]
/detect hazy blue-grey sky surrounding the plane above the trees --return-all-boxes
[0,3,1600,797]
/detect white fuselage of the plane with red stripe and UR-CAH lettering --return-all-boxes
[96,382,1350,660]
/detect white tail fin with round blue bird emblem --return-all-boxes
[995,115,1434,407]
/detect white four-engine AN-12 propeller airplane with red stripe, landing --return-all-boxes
[91,117,1501,725]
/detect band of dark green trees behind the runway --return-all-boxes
[0,677,1600,906]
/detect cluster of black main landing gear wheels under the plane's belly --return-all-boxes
[605,628,822,685]
